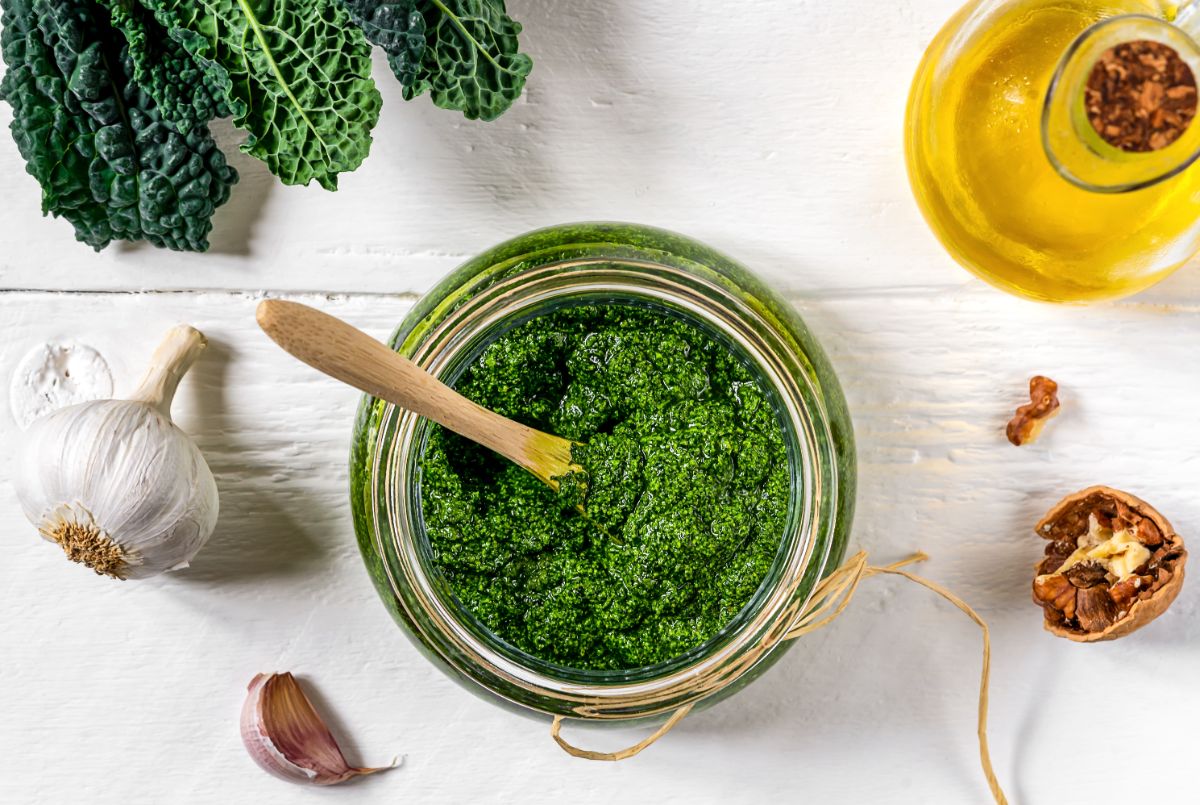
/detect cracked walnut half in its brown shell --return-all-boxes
[1033,486,1188,643]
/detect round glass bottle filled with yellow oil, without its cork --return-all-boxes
[906,0,1200,301]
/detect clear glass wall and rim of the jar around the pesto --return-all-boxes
[350,224,856,720]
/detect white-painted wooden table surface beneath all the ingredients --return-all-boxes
[0,0,1200,805]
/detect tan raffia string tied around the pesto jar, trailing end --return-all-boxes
[550,551,1008,805]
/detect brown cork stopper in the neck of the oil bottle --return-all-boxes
[1084,40,1196,154]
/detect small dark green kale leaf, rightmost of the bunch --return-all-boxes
[341,0,533,120]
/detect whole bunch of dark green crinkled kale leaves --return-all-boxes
[0,0,533,251]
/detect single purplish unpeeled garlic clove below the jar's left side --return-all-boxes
[241,673,396,786]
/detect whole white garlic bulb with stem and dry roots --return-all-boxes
[13,325,217,578]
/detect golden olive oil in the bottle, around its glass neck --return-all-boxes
[906,0,1200,301]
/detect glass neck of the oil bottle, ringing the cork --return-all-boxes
[1042,10,1200,193]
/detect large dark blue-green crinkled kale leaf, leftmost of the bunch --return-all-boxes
[0,0,238,251]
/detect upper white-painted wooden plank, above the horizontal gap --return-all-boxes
[0,0,1099,298]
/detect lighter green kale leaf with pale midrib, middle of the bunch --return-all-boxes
[140,0,382,190]
